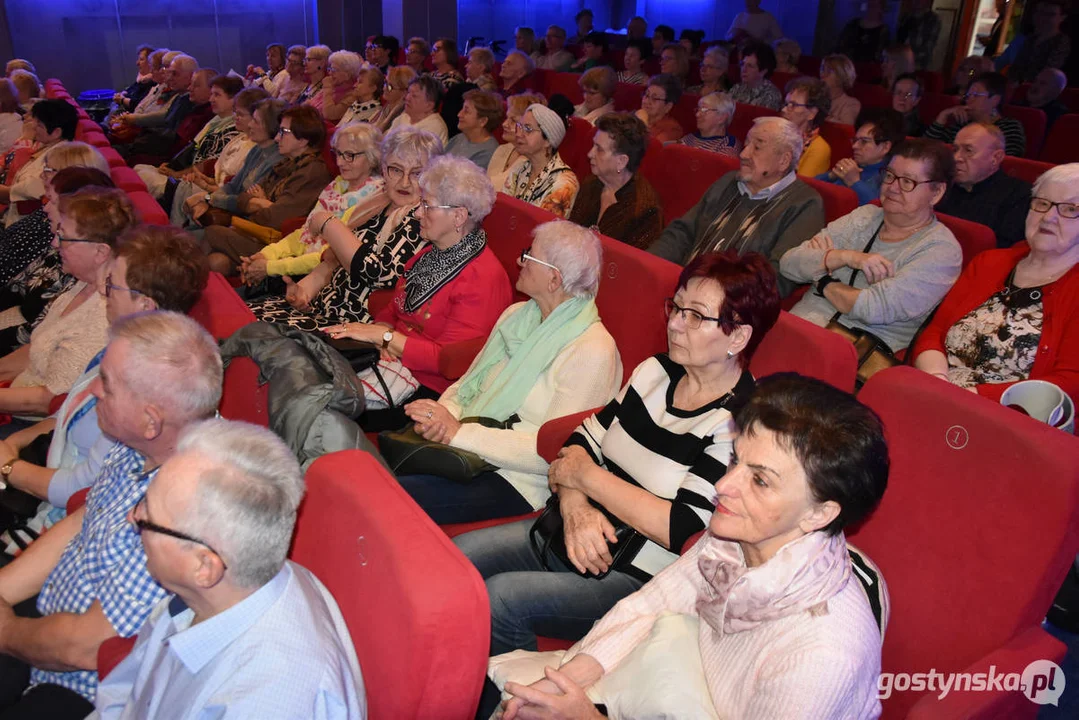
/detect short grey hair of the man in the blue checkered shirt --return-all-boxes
[109,310,224,425]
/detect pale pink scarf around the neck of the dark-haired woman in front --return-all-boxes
[697,531,850,635]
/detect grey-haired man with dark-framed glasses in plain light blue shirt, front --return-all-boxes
[91,420,367,720]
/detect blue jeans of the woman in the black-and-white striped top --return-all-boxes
[453,518,644,655]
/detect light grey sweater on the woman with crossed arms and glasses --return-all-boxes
[779,205,962,352]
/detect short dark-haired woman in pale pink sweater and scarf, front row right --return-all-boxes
[492,375,889,720]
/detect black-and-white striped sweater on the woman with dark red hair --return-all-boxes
[566,353,755,581]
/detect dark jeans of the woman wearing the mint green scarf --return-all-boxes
[397,472,532,525]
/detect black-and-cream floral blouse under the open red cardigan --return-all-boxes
[944,276,1043,388]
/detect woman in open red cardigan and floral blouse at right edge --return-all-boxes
[914,163,1079,402]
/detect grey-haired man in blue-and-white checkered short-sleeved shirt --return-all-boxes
[0,312,222,720]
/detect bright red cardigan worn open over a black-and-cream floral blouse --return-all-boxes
[913,242,1079,402]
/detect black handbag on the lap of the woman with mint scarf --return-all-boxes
[379,415,520,485]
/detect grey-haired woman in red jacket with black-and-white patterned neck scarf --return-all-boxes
[326,155,513,414]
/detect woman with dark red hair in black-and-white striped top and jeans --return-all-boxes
[455,253,779,655]
